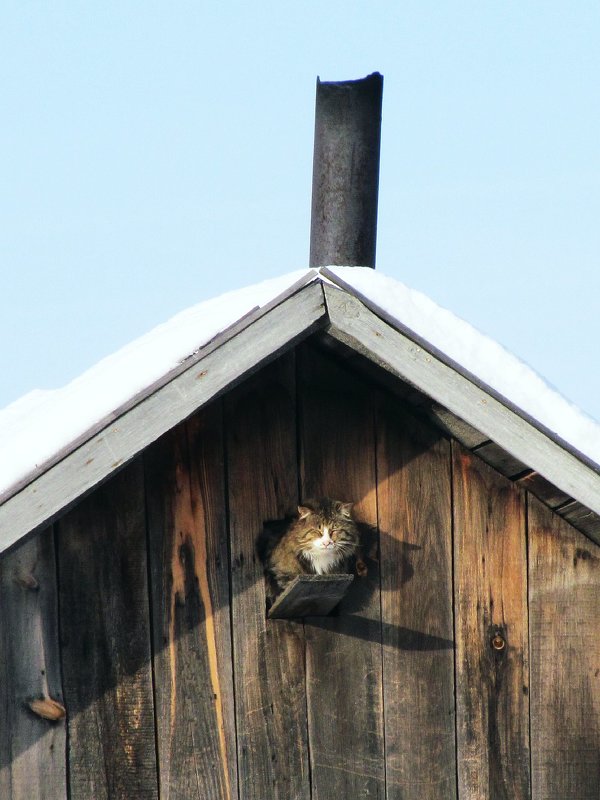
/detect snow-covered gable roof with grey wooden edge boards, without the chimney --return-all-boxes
[0,267,600,551]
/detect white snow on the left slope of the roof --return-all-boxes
[0,269,316,494]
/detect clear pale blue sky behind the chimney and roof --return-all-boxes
[0,0,600,419]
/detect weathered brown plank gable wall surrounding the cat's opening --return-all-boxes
[0,345,600,800]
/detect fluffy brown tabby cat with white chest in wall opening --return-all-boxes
[257,497,367,602]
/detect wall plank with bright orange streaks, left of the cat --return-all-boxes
[144,402,237,800]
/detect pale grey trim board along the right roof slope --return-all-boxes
[324,286,600,513]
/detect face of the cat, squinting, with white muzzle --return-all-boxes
[298,500,359,562]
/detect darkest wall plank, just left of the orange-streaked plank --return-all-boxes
[58,461,158,800]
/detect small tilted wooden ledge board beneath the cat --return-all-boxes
[269,574,354,619]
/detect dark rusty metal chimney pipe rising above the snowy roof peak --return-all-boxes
[310,72,383,269]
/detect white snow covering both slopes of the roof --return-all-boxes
[0,267,600,504]
